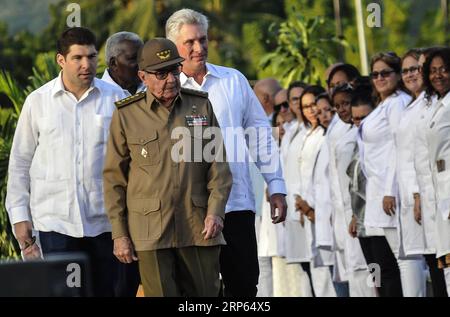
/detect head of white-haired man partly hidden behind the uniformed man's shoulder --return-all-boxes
[102,32,145,97]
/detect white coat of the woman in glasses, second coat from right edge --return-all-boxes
[395,93,436,256]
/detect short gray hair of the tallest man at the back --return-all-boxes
[166,9,208,43]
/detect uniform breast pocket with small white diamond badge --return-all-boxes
[127,131,160,165]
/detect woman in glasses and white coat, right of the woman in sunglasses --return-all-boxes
[396,49,447,297]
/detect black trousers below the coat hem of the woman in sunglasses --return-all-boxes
[359,237,403,297]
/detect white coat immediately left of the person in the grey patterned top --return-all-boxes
[330,125,367,273]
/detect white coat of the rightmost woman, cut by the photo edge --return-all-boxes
[426,93,450,257]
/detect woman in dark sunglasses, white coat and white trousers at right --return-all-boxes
[359,53,424,296]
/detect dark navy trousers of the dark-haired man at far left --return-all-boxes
[39,231,115,297]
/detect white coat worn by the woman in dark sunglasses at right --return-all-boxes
[358,91,411,228]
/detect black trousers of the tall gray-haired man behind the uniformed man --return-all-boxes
[220,211,259,297]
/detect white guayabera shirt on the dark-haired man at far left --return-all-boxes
[6,73,125,237]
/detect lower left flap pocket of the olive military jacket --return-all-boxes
[127,198,162,240]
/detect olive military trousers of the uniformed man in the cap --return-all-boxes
[137,246,220,297]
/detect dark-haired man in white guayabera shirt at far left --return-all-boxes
[6,27,125,296]
